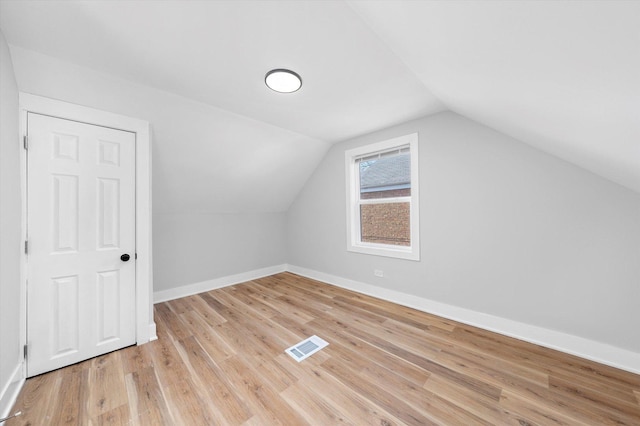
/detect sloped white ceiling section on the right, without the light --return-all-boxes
[350,0,640,192]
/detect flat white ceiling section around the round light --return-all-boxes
[0,0,444,142]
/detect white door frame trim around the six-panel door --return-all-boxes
[20,92,157,377]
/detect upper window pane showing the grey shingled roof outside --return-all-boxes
[358,151,411,200]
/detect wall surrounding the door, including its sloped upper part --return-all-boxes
[11,46,320,290]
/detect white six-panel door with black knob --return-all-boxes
[27,113,136,377]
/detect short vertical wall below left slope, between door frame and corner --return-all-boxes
[153,213,286,292]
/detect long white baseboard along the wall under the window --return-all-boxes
[287,265,640,374]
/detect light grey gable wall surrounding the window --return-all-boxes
[287,113,640,354]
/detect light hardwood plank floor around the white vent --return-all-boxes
[7,273,640,426]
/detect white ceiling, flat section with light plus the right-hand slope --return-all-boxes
[0,0,640,192]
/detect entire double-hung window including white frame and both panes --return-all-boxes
[345,133,420,260]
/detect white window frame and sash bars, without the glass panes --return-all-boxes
[345,133,420,260]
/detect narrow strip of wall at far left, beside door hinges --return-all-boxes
[0,33,22,418]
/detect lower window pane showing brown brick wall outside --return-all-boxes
[360,203,411,246]
